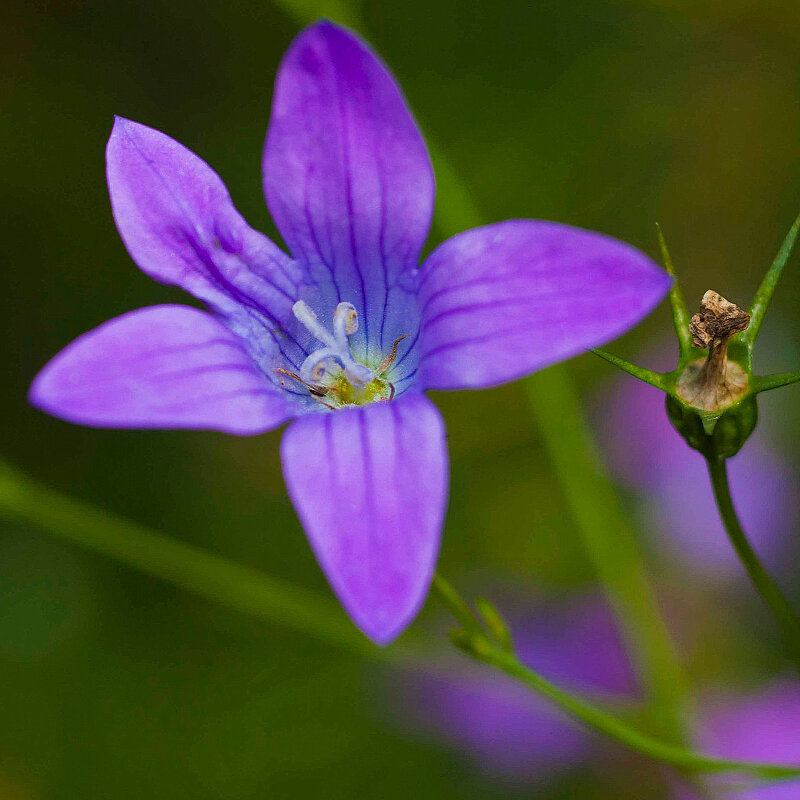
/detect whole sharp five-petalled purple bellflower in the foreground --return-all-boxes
[31,22,668,643]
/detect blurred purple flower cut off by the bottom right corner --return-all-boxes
[675,681,800,800]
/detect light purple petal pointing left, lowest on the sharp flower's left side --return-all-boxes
[29,306,290,434]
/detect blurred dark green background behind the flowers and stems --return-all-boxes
[0,0,800,800]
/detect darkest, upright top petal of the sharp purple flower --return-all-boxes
[264,22,434,348]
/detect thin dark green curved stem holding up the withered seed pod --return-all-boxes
[707,457,800,670]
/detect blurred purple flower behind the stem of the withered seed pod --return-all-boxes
[593,346,799,577]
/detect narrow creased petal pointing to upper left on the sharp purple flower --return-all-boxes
[106,117,304,365]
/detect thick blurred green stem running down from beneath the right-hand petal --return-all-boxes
[525,367,686,740]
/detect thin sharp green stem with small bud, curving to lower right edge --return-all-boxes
[434,575,800,779]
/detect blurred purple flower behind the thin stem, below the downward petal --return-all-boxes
[394,597,636,782]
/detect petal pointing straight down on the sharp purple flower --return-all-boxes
[281,394,447,644]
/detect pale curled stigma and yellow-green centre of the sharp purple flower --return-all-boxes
[276,300,406,409]
